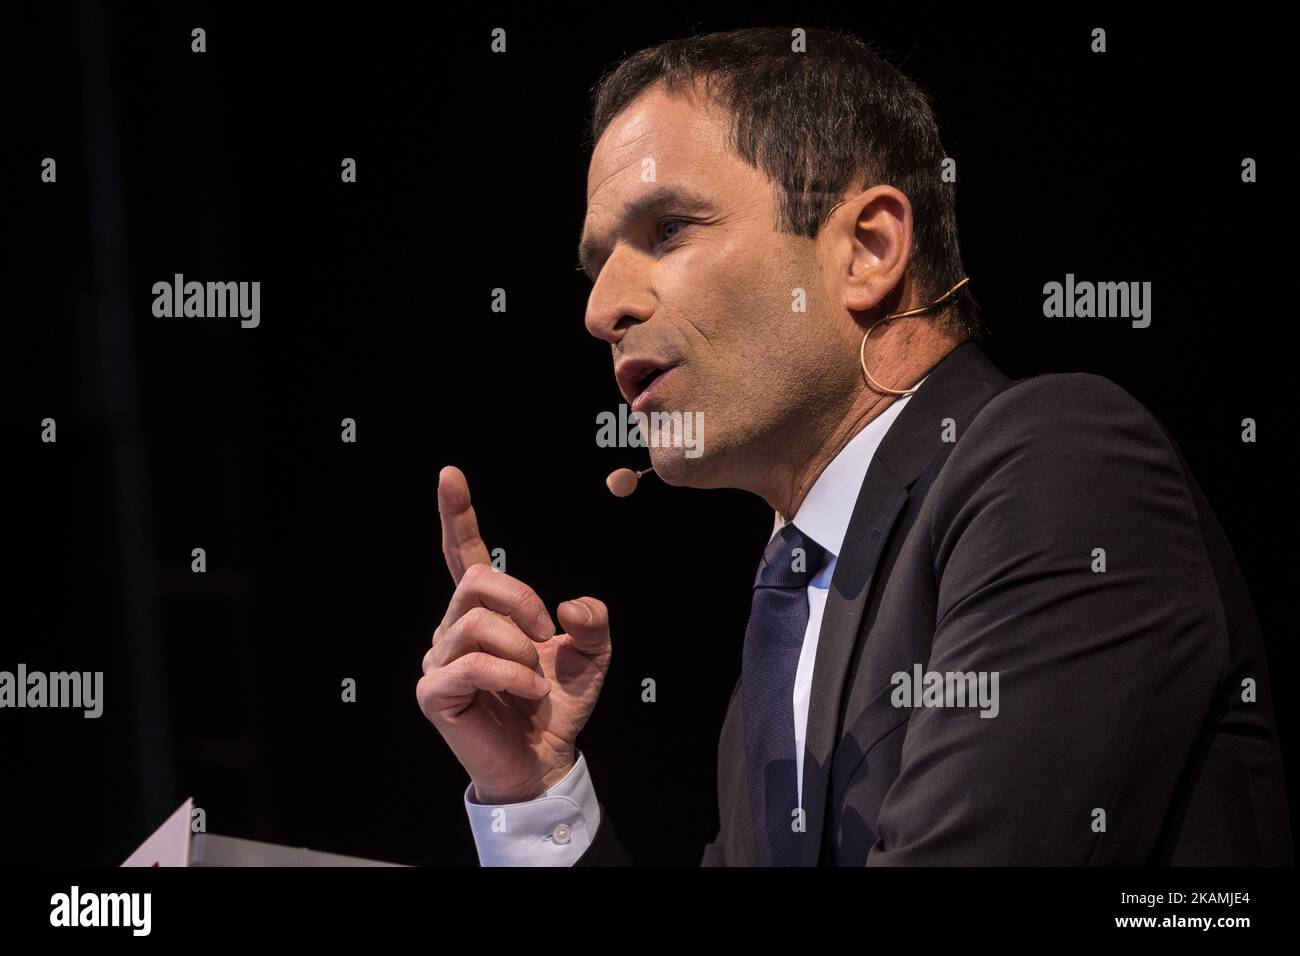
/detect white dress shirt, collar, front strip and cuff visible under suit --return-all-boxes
[465,375,930,866]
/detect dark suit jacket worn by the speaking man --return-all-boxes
[579,342,1291,866]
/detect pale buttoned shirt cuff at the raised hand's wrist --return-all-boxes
[465,750,601,866]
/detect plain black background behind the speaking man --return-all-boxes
[0,3,1300,865]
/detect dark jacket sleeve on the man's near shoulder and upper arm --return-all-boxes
[867,375,1227,866]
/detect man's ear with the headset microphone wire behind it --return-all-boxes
[823,186,911,312]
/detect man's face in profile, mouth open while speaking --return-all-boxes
[582,87,857,488]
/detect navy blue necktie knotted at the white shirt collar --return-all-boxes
[741,523,827,866]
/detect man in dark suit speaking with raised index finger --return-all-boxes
[417,30,1291,865]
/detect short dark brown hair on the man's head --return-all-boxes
[592,27,984,341]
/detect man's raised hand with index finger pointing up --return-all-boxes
[416,466,611,804]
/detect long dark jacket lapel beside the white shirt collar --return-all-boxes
[801,342,1010,866]
